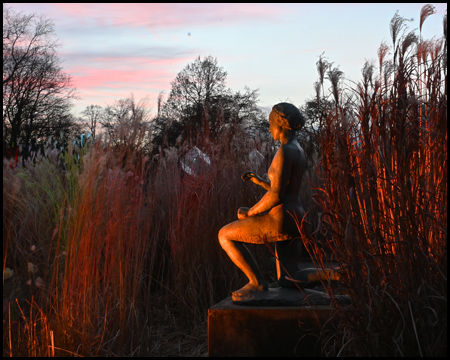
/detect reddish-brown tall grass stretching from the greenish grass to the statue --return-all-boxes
[56,124,274,354]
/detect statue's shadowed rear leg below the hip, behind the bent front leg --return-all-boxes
[275,239,300,287]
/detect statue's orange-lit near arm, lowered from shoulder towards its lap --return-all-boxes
[248,148,292,216]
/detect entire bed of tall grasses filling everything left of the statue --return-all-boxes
[3,109,270,356]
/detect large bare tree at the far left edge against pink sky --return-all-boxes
[3,6,76,156]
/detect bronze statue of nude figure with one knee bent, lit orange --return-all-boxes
[219,103,306,300]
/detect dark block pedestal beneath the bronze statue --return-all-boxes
[208,288,338,357]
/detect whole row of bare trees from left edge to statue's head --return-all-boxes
[3,5,268,158]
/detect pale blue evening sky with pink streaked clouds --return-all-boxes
[7,3,447,116]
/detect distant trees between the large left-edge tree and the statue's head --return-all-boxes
[75,56,268,155]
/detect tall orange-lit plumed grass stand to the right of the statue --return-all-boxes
[304,7,447,356]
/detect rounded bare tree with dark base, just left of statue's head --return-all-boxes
[154,56,264,147]
